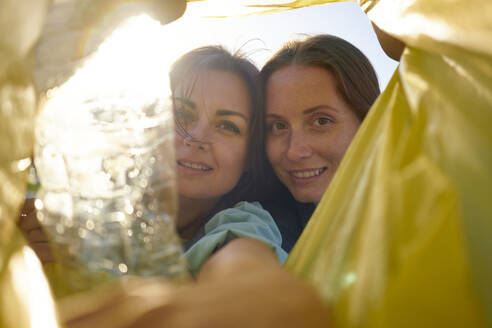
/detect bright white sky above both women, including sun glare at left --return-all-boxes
[55,0,397,102]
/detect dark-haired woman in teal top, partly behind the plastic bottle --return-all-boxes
[162,46,286,273]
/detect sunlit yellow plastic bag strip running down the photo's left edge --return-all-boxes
[0,0,58,328]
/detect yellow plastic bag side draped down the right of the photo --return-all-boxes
[286,0,492,327]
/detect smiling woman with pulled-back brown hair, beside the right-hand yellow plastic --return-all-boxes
[260,35,380,251]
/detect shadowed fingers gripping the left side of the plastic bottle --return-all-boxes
[17,199,54,263]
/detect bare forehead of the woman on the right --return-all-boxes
[266,65,347,112]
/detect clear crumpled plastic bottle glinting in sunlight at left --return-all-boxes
[34,90,187,291]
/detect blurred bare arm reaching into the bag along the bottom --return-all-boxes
[61,238,332,328]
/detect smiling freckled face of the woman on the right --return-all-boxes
[266,65,360,202]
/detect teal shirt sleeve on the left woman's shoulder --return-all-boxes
[185,202,287,275]
